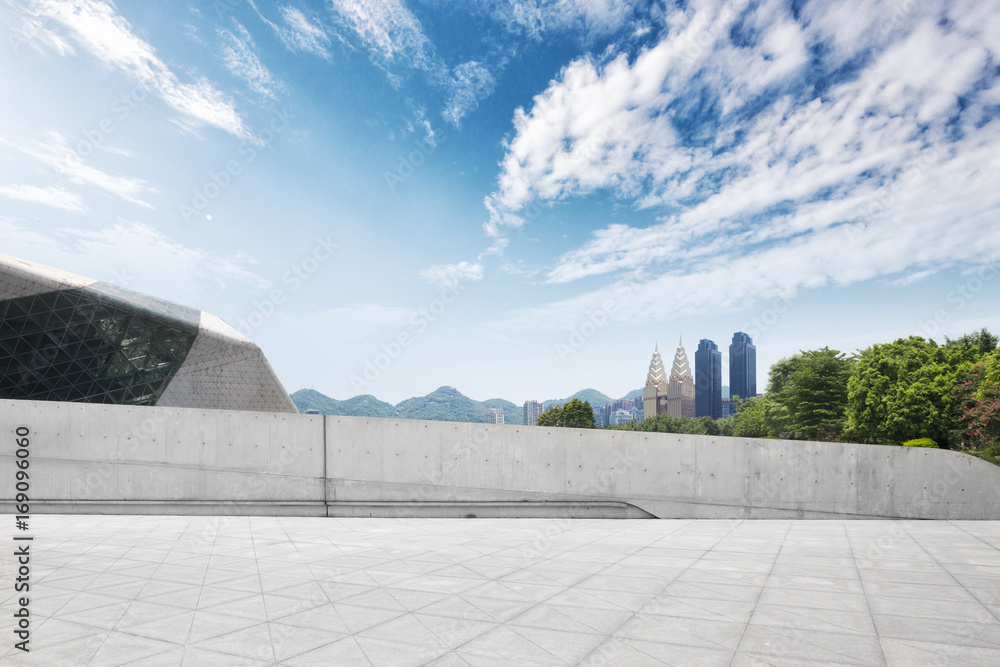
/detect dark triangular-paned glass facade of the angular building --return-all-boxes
[0,283,201,405]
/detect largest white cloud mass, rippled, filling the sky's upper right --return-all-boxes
[486,0,1000,326]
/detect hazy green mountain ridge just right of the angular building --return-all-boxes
[292,387,524,424]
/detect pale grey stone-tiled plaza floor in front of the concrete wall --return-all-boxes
[0,516,1000,667]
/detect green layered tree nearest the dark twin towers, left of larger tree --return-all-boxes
[767,347,853,439]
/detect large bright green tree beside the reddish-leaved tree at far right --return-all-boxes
[847,336,979,444]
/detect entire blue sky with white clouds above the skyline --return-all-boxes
[0,0,1000,403]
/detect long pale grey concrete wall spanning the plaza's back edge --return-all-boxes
[0,401,1000,520]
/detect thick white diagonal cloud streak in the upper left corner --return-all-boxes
[24,0,247,137]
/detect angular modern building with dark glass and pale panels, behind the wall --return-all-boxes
[0,254,298,412]
